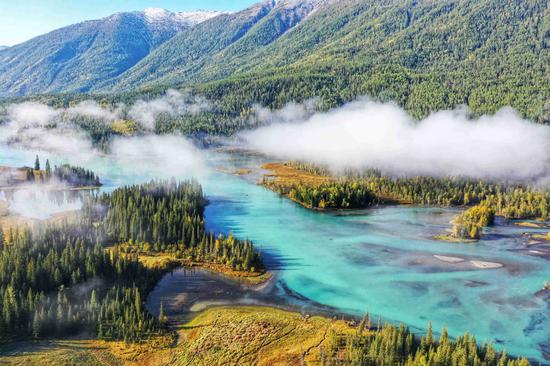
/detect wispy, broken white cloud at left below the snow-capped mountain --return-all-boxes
[0,90,209,158]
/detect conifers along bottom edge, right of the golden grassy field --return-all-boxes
[320,314,530,366]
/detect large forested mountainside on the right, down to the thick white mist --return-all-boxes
[108,0,550,122]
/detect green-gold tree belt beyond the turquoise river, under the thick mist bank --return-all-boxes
[262,161,550,239]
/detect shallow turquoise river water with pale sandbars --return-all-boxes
[0,148,550,360]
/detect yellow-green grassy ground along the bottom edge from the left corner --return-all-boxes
[0,307,353,366]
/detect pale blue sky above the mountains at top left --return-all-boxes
[0,0,258,46]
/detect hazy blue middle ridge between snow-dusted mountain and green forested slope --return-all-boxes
[102,0,338,90]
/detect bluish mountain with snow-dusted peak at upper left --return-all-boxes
[0,9,219,96]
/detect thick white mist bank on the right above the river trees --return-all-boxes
[241,100,550,181]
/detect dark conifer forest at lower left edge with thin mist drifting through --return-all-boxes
[0,223,161,341]
